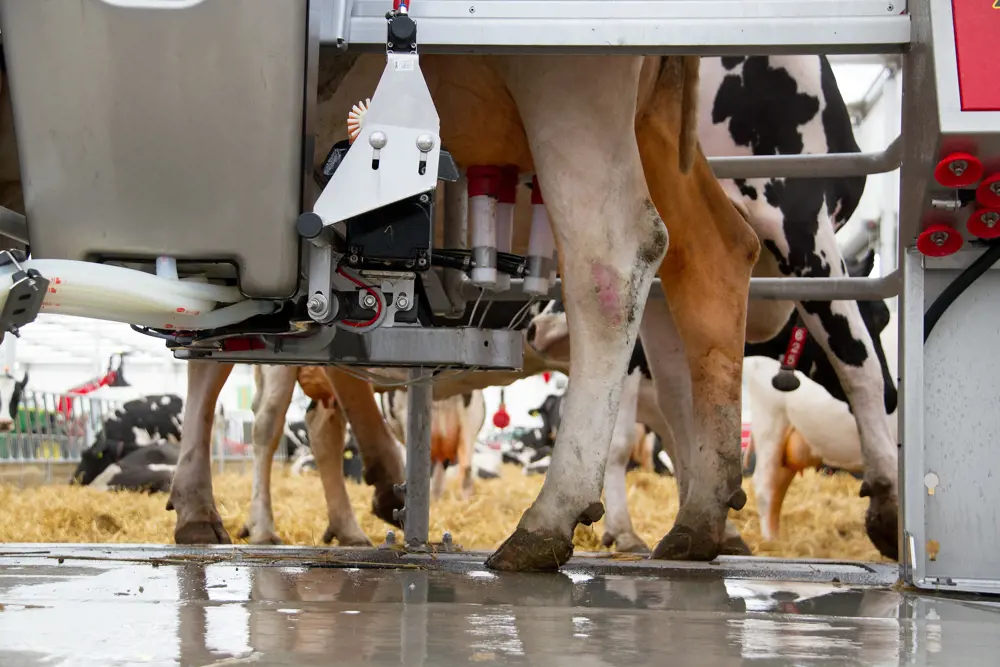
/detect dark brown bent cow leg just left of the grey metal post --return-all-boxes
[324,366,406,527]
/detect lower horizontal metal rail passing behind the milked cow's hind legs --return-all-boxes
[462,271,900,301]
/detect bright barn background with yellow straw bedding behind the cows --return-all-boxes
[0,56,900,560]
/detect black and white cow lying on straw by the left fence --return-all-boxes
[70,394,184,491]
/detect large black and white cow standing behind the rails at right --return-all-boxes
[529,56,898,558]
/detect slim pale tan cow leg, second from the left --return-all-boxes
[239,366,298,544]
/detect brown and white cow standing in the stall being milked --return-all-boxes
[169,49,760,570]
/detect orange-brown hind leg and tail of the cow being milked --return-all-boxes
[636,69,760,560]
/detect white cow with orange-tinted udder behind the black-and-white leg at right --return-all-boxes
[744,301,898,540]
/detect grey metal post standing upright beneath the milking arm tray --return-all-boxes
[403,367,432,548]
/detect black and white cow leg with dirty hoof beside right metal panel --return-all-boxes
[752,197,899,559]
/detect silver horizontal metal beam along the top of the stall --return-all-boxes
[321,0,919,55]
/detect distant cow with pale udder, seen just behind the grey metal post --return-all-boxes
[382,389,486,501]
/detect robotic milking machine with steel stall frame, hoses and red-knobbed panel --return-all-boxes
[0,0,1000,592]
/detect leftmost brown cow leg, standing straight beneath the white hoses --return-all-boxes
[167,361,233,544]
